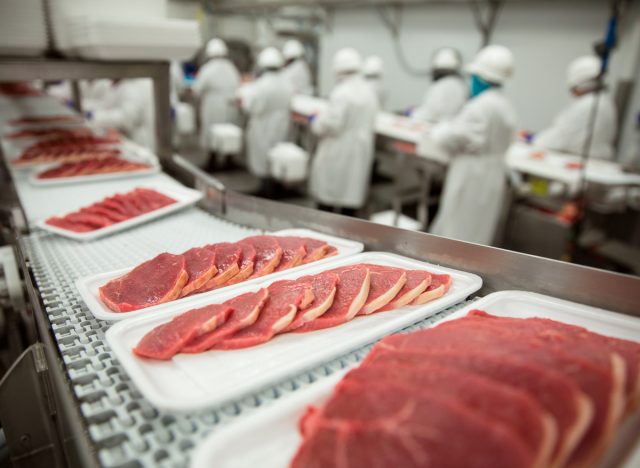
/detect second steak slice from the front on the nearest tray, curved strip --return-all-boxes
[340,361,557,466]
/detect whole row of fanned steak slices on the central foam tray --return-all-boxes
[133,264,451,360]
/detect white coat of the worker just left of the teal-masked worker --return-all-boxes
[411,75,469,123]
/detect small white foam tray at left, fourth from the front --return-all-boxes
[36,184,202,241]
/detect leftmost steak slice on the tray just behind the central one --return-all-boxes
[100,253,189,312]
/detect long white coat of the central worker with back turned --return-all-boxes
[310,75,378,208]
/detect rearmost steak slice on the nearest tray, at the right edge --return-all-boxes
[469,310,640,409]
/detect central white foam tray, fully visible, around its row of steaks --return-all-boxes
[106,252,482,412]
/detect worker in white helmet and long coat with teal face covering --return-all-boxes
[430,45,516,244]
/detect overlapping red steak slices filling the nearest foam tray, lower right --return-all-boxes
[291,310,640,468]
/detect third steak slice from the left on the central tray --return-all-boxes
[212,280,313,349]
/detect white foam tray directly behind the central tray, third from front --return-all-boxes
[76,229,364,321]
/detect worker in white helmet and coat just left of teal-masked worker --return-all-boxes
[411,47,469,123]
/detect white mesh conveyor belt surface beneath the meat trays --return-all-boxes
[22,208,472,467]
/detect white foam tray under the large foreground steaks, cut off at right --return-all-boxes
[190,291,640,468]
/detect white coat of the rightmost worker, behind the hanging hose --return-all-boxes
[533,91,617,160]
